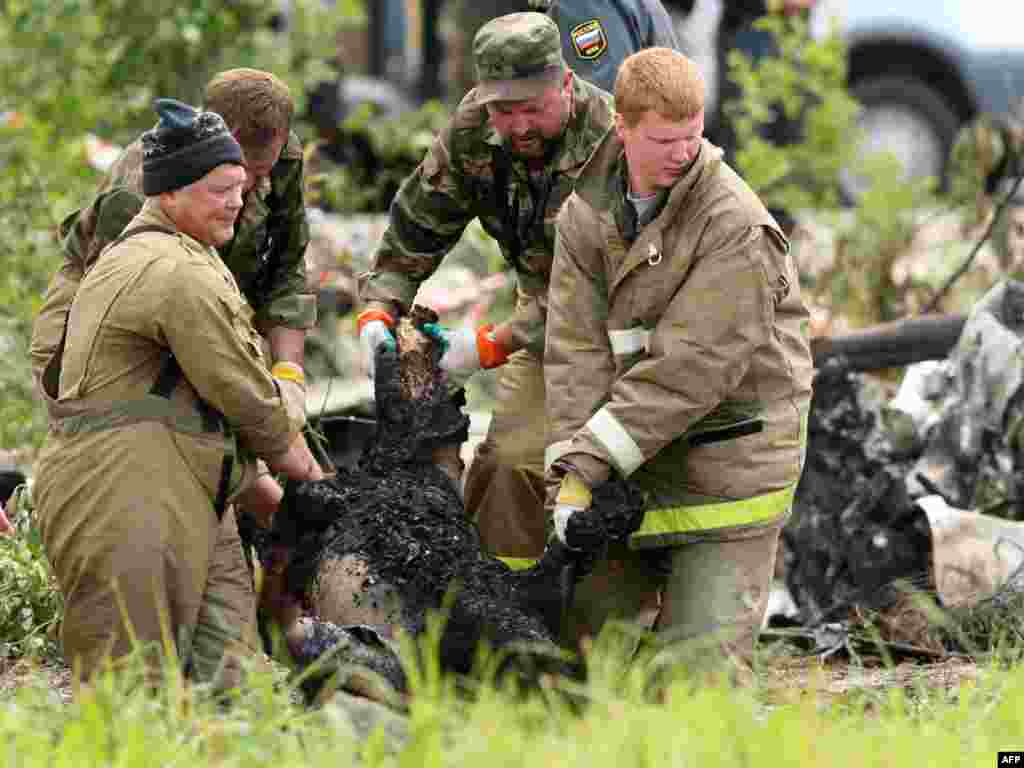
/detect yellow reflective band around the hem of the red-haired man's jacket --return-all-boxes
[630,483,797,541]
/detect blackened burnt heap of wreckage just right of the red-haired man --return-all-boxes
[782,364,934,625]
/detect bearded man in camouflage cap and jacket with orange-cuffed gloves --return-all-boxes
[358,12,612,562]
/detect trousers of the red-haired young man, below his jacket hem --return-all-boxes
[563,517,785,679]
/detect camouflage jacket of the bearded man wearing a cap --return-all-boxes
[359,78,613,354]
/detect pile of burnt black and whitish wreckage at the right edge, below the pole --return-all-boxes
[769,281,1024,655]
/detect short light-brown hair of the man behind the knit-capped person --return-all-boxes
[204,68,295,148]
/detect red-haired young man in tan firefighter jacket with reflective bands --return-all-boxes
[545,48,812,679]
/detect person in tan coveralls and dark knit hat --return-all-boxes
[35,99,321,685]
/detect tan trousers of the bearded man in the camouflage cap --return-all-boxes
[465,350,547,565]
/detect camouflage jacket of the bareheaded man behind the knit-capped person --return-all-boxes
[60,133,316,329]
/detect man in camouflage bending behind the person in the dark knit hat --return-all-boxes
[32,69,316,380]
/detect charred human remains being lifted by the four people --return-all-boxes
[263,307,642,690]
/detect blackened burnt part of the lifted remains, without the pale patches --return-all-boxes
[274,325,643,684]
